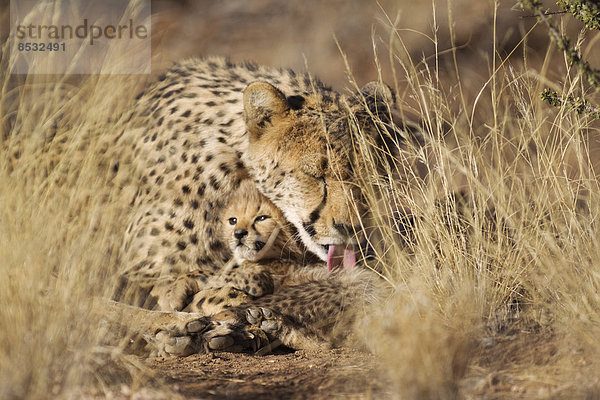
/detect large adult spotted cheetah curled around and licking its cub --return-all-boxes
[109,58,404,354]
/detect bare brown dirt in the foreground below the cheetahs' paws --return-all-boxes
[146,349,388,399]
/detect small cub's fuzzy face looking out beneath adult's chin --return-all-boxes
[222,180,293,261]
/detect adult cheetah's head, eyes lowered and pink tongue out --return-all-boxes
[244,82,394,269]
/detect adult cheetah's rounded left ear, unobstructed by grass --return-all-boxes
[244,82,289,139]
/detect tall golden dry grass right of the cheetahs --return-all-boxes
[358,7,600,399]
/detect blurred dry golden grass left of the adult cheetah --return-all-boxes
[0,42,154,399]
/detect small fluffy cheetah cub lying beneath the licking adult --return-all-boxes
[150,179,384,355]
